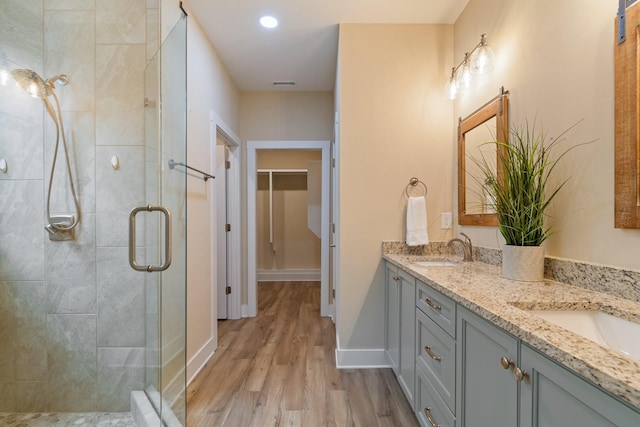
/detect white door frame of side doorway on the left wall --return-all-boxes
[209,111,242,320]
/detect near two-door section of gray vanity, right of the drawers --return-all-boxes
[456,307,640,427]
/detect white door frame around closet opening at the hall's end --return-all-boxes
[242,140,333,317]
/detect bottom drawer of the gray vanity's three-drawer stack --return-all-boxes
[415,366,456,427]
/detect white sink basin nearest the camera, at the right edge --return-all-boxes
[529,310,640,360]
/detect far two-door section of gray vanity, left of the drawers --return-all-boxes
[385,264,416,408]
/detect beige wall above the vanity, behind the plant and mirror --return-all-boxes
[452,0,640,269]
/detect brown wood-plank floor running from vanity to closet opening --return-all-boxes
[187,282,418,427]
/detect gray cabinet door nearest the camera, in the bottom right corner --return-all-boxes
[520,344,640,427]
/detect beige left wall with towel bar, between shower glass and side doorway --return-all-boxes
[187,11,239,376]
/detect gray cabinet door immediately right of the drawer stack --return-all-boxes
[456,306,518,427]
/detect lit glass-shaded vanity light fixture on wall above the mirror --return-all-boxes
[444,34,494,99]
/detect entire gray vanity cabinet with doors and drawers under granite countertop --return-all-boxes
[385,263,640,427]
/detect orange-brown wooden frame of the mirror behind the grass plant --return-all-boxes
[458,87,509,226]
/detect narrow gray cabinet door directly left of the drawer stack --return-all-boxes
[398,271,416,408]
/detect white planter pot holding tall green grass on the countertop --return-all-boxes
[502,245,544,282]
